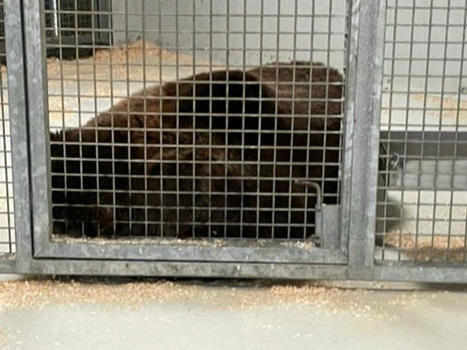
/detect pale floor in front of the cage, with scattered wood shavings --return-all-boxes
[0,281,467,350]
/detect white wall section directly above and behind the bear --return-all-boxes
[113,0,347,68]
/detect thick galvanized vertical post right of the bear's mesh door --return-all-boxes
[346,0,383,271]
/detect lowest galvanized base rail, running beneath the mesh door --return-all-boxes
[4,259,467,283]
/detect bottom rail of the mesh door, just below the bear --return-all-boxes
[34,239,346,264]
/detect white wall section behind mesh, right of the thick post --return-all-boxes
[385,0,467,94]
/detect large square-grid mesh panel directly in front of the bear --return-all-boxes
[45,0,348,240]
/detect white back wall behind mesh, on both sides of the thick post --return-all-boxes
[112,0,467,93]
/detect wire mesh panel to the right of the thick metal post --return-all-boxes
[376,0,467,264]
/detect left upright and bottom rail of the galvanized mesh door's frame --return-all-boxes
[24,1,352,264]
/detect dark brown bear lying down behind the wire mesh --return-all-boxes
[50,61,344,239]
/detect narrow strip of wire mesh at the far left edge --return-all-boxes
[0,1,15,257]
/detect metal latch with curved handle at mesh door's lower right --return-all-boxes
[295,179,340,249]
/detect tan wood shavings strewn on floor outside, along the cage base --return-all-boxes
[0,277,428,318]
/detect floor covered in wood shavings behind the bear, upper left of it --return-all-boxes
[47,40,217,128]
